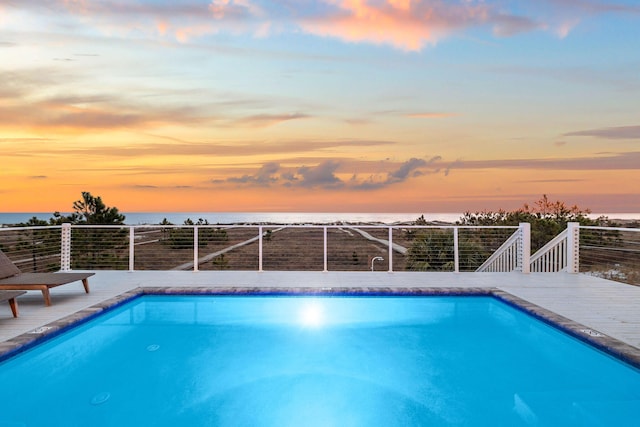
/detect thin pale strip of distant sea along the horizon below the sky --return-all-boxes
[0,212,640,225]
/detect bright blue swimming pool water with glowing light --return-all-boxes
[0,296,640,427]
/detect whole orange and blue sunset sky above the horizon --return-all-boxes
[0,0,640,213]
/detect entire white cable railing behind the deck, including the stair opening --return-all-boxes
[0,223,640,284]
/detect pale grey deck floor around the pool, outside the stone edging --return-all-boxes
[0,271,640,349]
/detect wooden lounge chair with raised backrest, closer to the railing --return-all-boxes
[0,251,95,306]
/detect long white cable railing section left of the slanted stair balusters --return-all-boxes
[0,224,528,272]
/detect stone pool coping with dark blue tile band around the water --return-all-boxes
[0,286,640,369]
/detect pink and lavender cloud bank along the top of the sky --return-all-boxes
[11,0,640,51]
